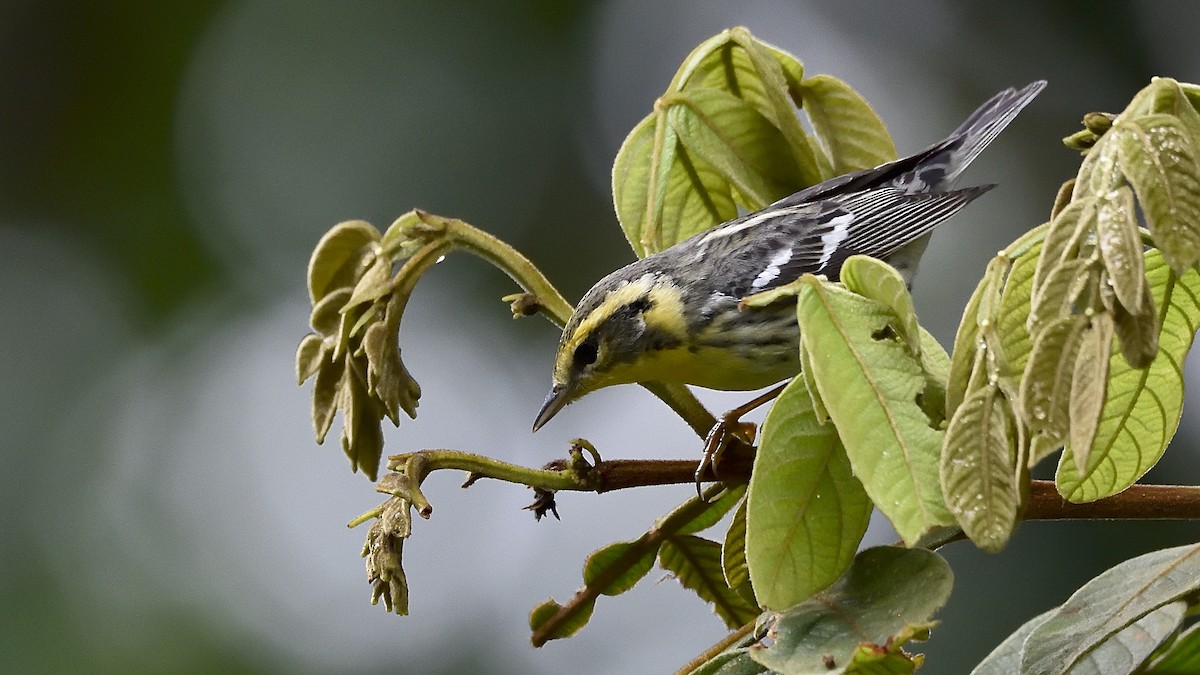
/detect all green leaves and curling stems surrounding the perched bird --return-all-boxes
[296,29,1200,673]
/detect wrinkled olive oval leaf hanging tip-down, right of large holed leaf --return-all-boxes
[941,386,1021,552]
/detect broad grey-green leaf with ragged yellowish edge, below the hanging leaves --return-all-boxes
[750,546,954,673]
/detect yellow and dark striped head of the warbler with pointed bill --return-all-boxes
[533,263,686,431]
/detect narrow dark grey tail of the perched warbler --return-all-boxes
[893,79,1046,190]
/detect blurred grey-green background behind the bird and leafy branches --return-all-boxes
[7,0,1200,674]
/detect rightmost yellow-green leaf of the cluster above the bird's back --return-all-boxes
[800,74,896,175]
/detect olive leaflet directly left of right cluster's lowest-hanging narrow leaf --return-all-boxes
[1019,316,1087,438]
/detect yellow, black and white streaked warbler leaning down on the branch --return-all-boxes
[533,80,1045,431]
